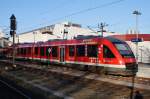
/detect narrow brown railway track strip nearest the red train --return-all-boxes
[0,60,150,89]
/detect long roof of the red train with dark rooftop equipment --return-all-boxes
[17,35,124,47]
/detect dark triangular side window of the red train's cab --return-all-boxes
[103,45,115,58]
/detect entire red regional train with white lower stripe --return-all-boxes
[7,36,138,74]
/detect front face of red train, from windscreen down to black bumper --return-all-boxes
[113,41,138,74]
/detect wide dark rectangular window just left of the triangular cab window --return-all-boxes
[87,45,98,57]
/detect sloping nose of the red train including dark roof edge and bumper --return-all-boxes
[106,37,138,75]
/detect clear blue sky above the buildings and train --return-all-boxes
[0,0,150,33]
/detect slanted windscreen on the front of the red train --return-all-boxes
[115,43,135,58]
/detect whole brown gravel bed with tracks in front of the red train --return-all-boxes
[0,59,150,99]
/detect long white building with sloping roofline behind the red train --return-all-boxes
[10,22,113,43]
